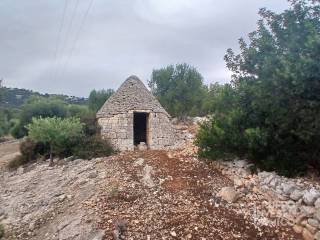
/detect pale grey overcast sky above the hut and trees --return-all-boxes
[0,0,288,96]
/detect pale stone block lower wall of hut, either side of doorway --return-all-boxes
[98,110,176,151]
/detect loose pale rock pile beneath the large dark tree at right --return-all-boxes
[213,160,320,240]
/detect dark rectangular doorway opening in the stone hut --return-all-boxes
[133,112,148,145]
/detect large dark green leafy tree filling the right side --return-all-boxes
[197,0,320,175]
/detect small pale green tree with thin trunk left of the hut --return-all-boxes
[27,117,83,165]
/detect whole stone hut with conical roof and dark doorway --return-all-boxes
[97,76,175,151]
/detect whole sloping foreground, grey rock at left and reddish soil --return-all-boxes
[0,148,299,240]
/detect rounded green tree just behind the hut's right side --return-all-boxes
[148,63,206,118]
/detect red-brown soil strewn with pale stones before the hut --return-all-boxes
[88,151,300,240]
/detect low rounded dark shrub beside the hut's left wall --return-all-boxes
[73,135,114,159]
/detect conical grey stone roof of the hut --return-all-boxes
[97,76,169,118]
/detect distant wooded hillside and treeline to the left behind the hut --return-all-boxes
[0,87,113,138]
